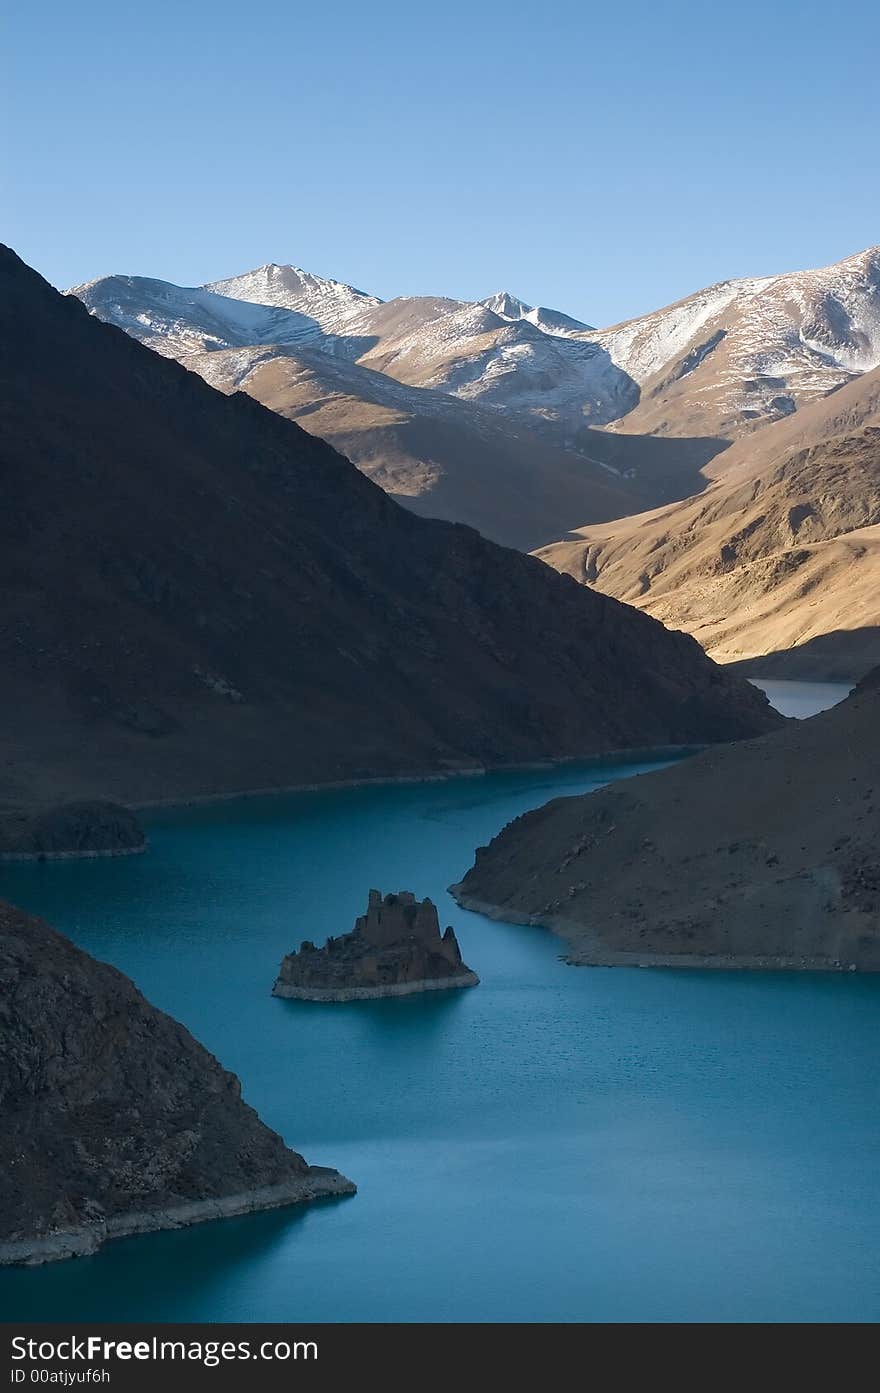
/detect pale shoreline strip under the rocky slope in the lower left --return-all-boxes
[0,1166,356,1268]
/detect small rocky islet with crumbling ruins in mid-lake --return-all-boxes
[273,890,479,1002]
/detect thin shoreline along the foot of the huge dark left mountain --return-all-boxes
[132,745,709,813]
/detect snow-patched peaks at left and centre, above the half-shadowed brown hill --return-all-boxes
[71,266,639,447]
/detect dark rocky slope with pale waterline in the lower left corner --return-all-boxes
[0,905,355,1263]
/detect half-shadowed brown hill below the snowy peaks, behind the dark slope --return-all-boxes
[165,339,648,550]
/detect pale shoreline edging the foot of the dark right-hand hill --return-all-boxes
[448,882,880,972]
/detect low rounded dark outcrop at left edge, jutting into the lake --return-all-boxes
[0,798,146,861]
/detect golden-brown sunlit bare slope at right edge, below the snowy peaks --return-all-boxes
[537,371,880,678]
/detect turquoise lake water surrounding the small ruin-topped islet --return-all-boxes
[0,679,880,1321]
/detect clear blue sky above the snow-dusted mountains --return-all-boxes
[0,0,880,325]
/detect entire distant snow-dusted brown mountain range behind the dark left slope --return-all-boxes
[72,248,880,678]
